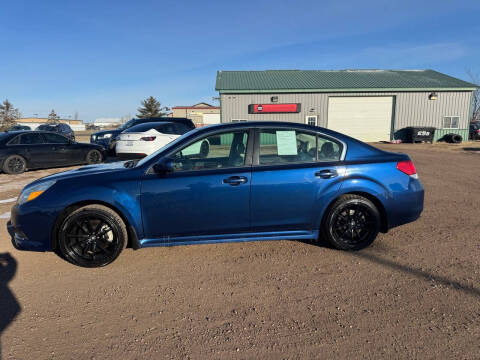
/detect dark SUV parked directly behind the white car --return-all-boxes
[90,117,195,155]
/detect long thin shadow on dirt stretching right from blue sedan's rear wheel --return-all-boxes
[301,240,480,298]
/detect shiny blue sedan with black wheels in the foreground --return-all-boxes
[7,122,424,267]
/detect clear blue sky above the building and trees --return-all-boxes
[0,0,480,121]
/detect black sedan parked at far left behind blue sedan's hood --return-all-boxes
[0,131,104,174]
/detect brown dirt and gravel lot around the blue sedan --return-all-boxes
[0,142,480,359]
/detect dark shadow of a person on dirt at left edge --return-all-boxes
[0,253,21,359]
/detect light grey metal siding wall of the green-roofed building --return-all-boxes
[220,91,472,139]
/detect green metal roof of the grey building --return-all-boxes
[215,70,477,93]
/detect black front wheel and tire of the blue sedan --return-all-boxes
[57,205,128,268]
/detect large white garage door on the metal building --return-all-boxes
[328,96,393,142]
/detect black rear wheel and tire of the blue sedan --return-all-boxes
[321,195,381,250]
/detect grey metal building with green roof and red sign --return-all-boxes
[215,70,476,141]
